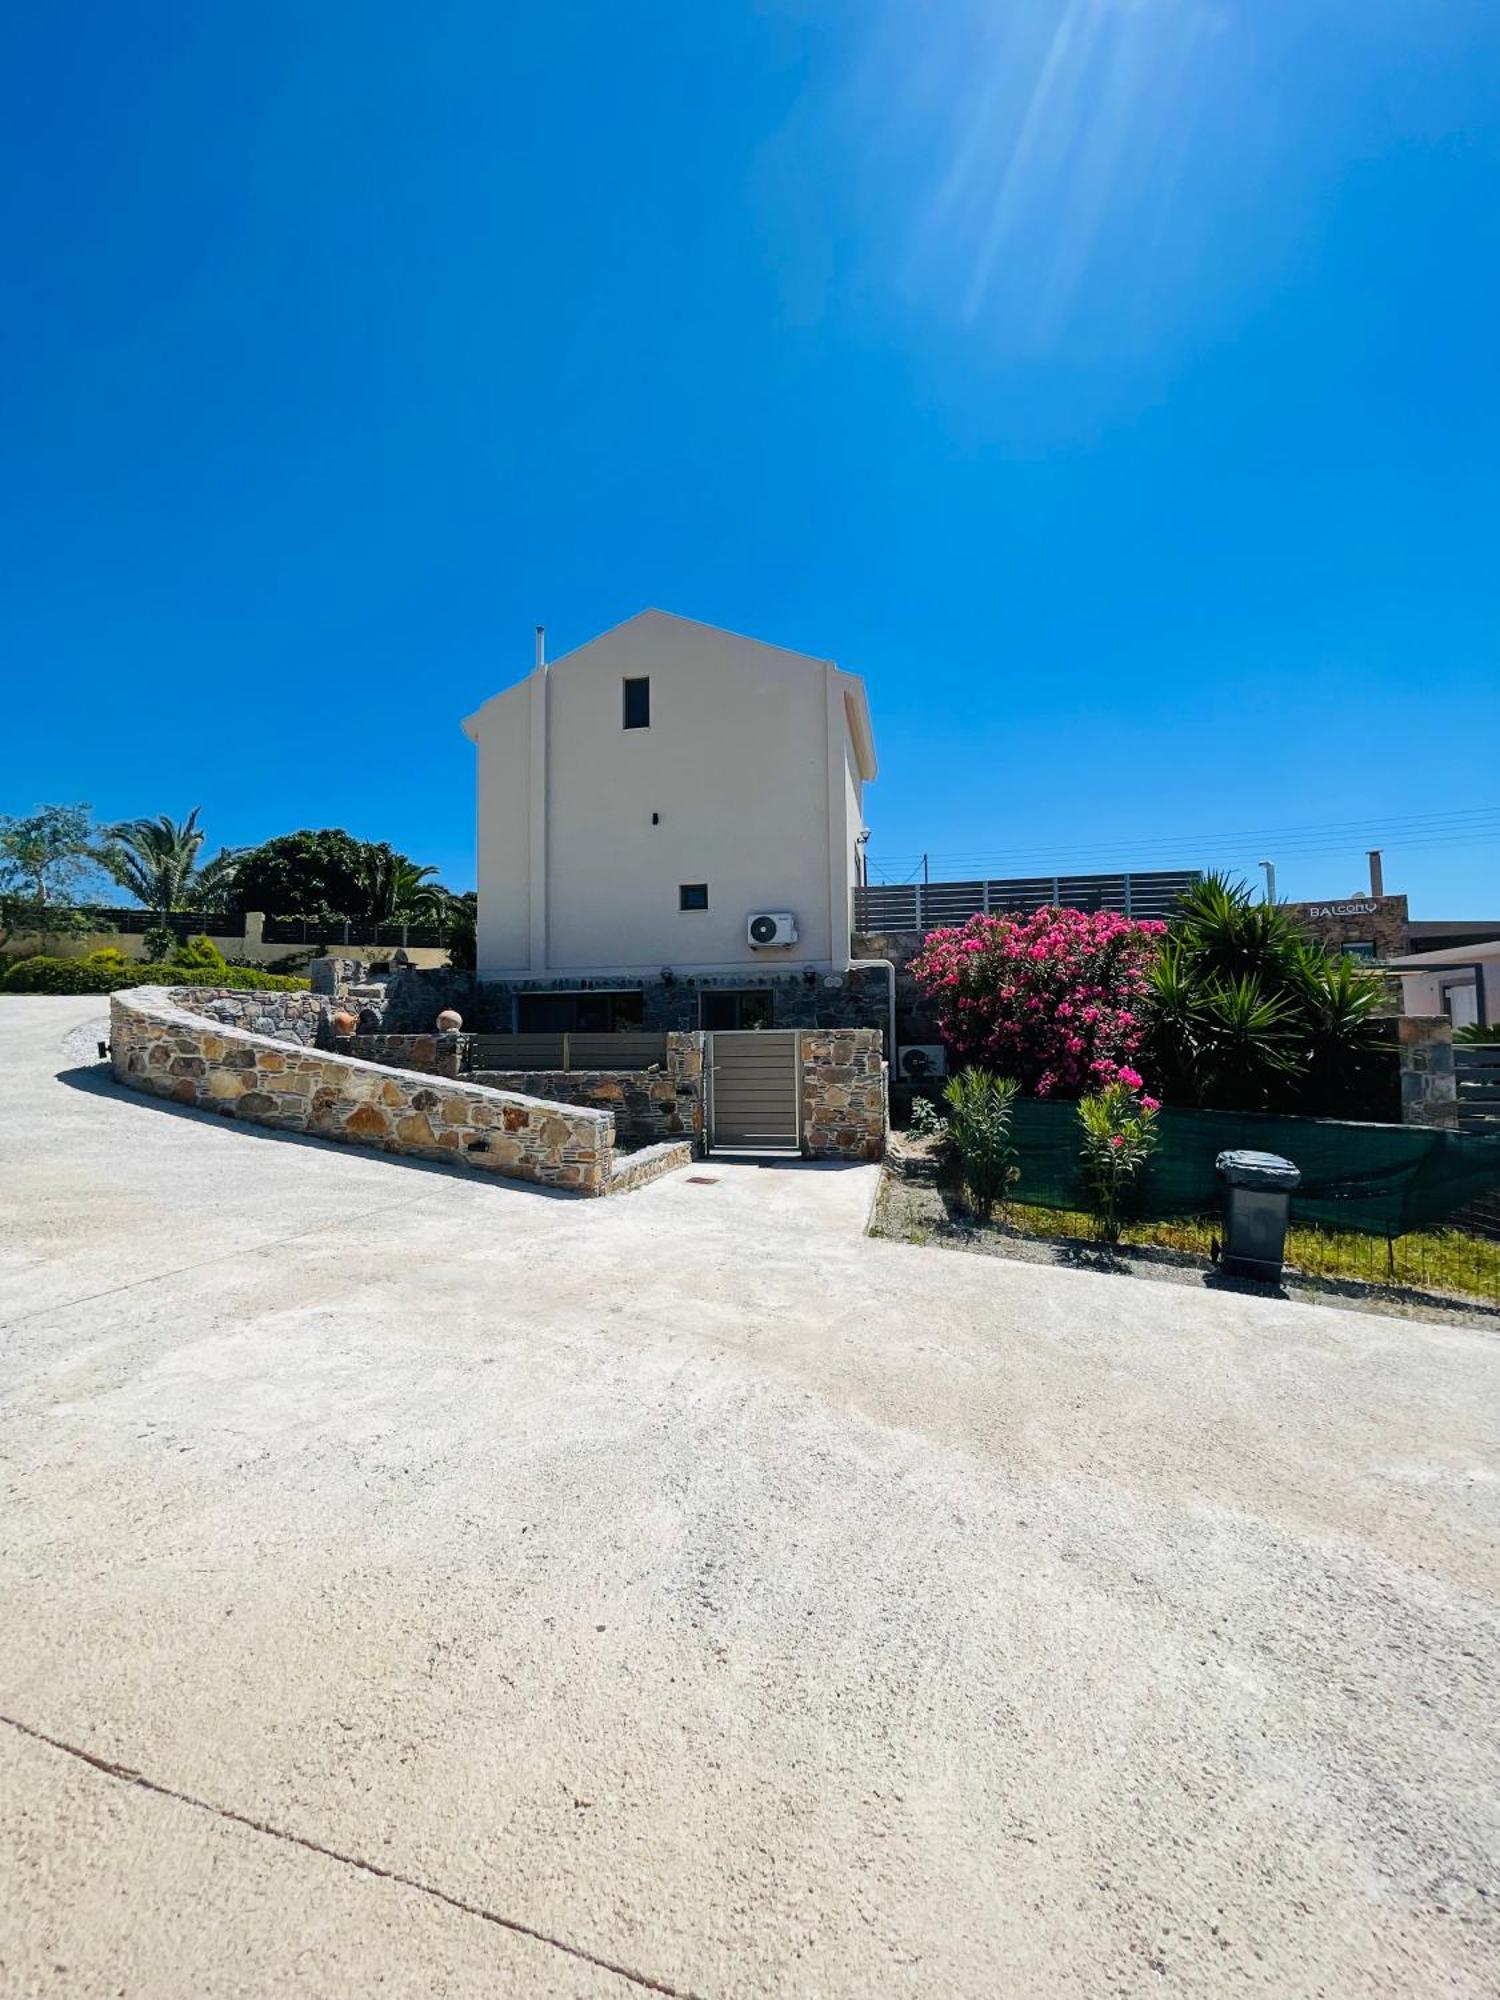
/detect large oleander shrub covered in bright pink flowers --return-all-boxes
[912,910,1166,1098]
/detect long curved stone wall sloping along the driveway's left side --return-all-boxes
[110,986,614,1194]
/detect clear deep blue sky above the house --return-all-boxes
[0,0,1500,916]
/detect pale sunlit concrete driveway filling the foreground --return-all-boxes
[0,998,1500,2000]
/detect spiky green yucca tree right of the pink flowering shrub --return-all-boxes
[1142,876,1384,1116]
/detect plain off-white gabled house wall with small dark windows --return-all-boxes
[464,612,876,978]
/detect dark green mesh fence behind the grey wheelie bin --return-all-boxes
[1012,1098,1500,1236]
